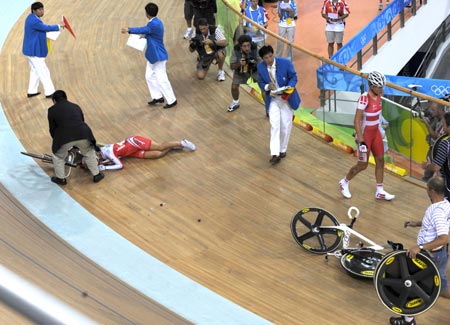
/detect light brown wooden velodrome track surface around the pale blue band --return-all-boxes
[0,0,450,324]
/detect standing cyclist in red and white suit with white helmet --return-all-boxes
[339,71,395,201]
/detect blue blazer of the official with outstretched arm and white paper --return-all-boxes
[129,17,169,64]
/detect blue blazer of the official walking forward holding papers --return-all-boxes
[258,57,302,112]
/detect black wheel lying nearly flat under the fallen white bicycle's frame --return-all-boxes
[341,249,384,279]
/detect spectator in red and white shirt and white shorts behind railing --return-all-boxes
[322,0,350,58]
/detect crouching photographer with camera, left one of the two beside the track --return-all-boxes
[189,18,228,81]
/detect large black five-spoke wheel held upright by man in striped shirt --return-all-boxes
[374,250,441,316]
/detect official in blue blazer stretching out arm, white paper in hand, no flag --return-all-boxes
[121,2,177,108]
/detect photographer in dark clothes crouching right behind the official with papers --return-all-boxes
[228,35,261,112]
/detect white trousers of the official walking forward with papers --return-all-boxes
[269,96,294,156]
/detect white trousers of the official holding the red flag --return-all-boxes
[27,56,55,96]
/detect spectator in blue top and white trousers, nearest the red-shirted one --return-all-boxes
[276,0,297,61]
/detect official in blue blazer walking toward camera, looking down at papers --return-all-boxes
[257,45,301,165]
